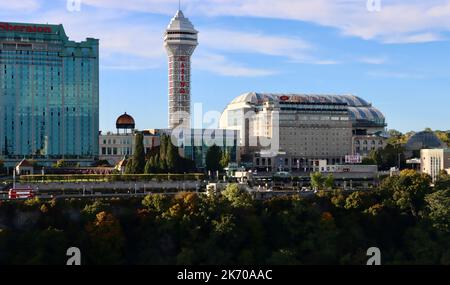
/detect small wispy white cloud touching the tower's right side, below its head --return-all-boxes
[192,54,277,77]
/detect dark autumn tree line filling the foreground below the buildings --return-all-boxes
[0,171,450,265]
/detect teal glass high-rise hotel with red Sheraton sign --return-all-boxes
[0,23,99,159]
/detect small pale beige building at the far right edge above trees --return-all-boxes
[420,148,450,182]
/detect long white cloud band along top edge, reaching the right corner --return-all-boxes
[76,0,450,43]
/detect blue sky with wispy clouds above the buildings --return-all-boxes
[0,0,450,131]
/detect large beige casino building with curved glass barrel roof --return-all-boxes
[219,92,386,171]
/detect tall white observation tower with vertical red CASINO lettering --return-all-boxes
[164,10,198,129]
